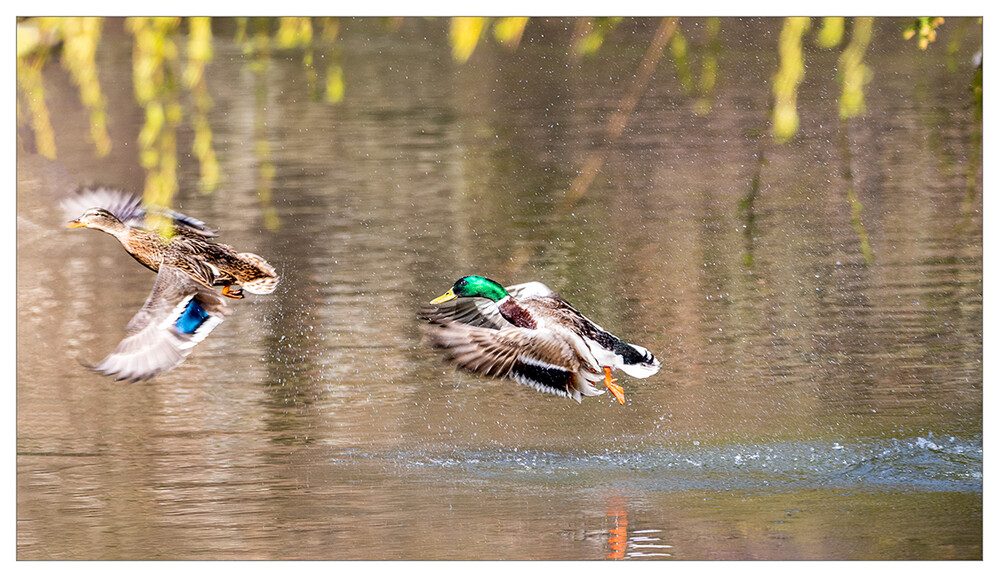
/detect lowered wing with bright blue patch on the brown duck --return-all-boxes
[92,265,228,381]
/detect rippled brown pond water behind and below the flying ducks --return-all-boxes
[17,20,983,559]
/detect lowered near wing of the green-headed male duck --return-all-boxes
[424,319,603,402]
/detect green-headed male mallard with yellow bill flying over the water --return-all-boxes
[421,276,659,404]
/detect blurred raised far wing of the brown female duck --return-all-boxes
[61,187,218,238]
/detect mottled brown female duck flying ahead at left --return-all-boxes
[63,188,279,381]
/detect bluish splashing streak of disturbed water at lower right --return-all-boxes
[386,433,983,493]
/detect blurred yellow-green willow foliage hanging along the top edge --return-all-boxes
[17,17,982,231]
